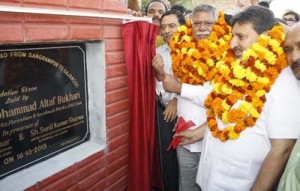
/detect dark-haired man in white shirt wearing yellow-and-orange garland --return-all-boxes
[197,6,300,191]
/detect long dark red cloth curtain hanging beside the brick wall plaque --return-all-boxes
[122,21,162,191]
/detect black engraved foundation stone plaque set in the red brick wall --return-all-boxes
[0,43,90,179]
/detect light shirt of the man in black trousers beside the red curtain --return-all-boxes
[156,43,177,106]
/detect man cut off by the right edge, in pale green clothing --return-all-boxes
[278,23,300,191]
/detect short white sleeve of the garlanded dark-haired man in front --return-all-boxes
[265,67,300,139]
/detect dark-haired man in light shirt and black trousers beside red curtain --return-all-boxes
[152,10,185,191]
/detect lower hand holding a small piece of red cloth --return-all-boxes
[175,123,207,145]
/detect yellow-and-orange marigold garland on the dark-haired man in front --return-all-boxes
[205,25,287,141]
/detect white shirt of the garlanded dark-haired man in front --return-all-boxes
[197,67,300,191]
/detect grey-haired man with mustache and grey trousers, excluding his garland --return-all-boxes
[153,4,218,191]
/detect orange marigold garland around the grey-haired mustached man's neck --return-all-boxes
[170,12,231,85]
